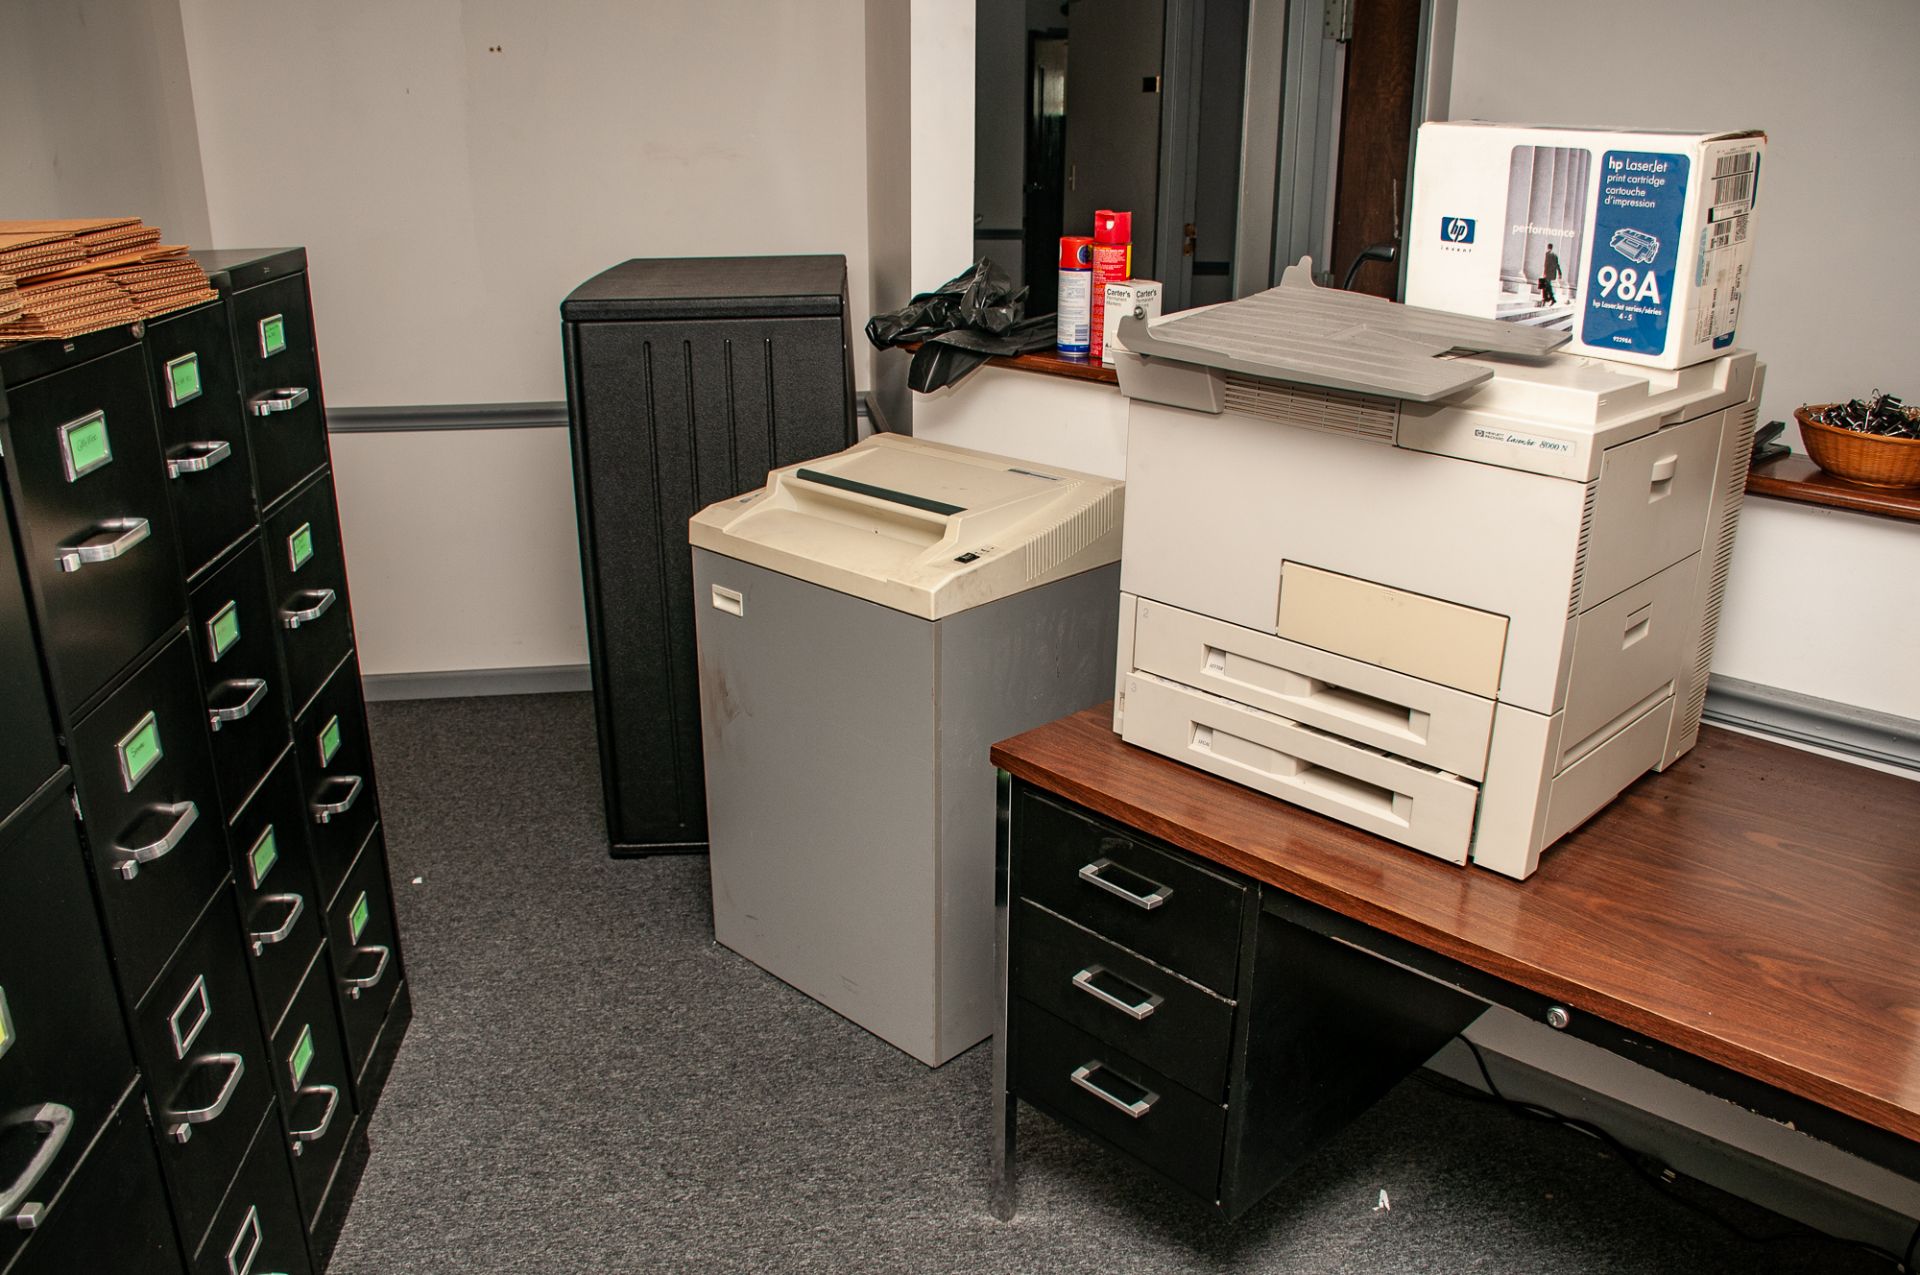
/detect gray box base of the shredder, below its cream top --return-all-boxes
[693,549,1119,1066]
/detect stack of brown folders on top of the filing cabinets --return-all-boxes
[0,217,215,344]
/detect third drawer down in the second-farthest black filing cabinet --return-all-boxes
[230,749,326,1031]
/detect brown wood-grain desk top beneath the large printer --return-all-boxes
[993,707,1920,1141]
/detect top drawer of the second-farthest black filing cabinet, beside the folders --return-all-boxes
[146,301,255,578]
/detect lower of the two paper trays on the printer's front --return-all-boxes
[1121,674,1480,864]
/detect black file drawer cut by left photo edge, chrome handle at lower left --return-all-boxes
[0,789,134,1267]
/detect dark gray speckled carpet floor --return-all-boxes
[330,695,1891,1275]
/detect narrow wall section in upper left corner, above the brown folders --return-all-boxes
[0,0,209,248]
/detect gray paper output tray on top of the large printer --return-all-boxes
[1119,259,1571,403]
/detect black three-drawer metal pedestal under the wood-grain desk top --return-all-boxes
[998,780,1484,1217]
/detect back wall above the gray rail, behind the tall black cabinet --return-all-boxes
[180,0,868,405]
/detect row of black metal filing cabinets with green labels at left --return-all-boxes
[0,250,411,1275]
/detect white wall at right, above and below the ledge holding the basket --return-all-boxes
[1452,0,1920,718]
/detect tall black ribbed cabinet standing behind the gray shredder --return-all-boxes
[561,255,854,854]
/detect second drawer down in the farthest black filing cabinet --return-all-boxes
[263,474,353,714]
